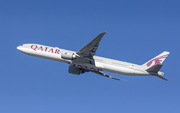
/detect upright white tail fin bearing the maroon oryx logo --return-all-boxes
[142,51,169,69]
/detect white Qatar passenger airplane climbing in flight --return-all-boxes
[17,32,170,81]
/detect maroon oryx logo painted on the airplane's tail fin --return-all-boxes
[146,54,168,67]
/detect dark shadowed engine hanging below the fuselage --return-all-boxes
[68,66,84,75]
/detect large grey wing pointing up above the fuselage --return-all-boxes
[75,32,106,64]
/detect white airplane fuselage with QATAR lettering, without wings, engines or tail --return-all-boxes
[17,44,151,76]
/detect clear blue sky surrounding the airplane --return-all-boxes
[0,0,180,113]
